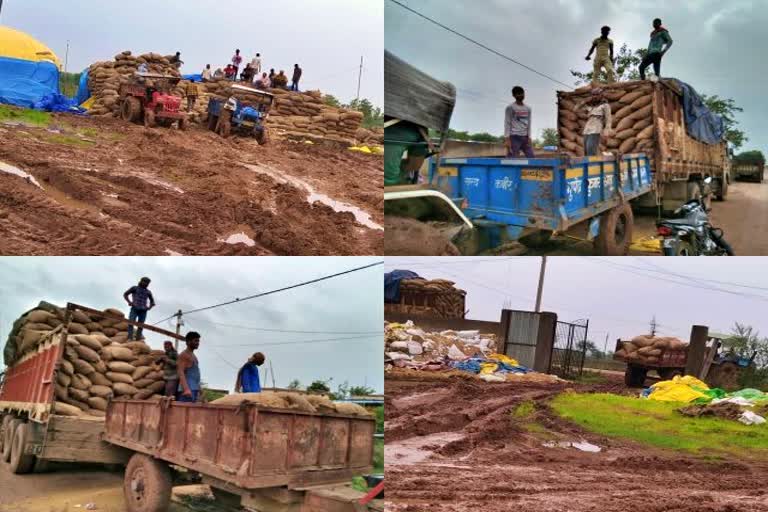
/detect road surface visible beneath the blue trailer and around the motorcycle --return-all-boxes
[525,182,768,256]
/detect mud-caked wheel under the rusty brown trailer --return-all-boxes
[123,453,171,512]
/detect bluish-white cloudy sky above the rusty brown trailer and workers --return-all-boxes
[0,256,384,392]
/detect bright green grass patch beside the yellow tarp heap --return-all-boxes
[552,393,768,459]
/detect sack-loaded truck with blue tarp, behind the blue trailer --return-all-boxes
[557,79,731,211]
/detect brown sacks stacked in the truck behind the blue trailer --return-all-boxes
[557,81,654,156]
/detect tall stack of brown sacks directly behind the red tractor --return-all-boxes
[88,50,180,117]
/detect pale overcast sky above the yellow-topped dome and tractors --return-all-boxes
[0,0,384,106]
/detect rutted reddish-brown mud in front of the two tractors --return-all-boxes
[0,114,383,255]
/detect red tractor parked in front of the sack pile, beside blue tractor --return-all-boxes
[120,73,189,130]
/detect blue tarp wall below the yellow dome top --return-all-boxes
[0,57,59,108]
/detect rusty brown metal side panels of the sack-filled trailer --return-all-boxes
[105,400,375,489]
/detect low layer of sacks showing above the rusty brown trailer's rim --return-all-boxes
[211,391,371,417]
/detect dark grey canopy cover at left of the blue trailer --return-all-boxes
[384,51,456,131]
